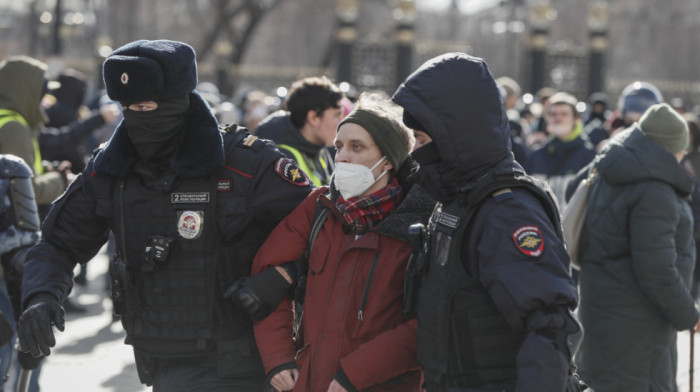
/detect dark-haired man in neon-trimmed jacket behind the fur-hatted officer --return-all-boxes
[255,76,343,186]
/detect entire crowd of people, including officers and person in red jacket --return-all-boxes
[0,40,700,392]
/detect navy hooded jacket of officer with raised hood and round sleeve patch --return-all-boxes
[393,53,580,392]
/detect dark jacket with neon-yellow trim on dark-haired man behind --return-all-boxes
[255,110,334,186]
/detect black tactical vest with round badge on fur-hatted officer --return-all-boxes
[90,132,279,362]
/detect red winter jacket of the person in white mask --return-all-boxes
[252,187,433,392]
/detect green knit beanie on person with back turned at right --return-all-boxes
[639,103,688,154]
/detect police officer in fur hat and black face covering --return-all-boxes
[19,40,311,391]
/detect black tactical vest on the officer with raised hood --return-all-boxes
[417,175,561,390]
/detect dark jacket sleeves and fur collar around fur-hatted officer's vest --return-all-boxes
[23,92,311,312]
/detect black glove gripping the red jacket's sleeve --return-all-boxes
[224,267,291,321]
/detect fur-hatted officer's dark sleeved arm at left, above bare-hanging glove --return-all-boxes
[22,170,108,304]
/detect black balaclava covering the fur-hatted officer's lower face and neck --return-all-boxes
[124,95,190,163]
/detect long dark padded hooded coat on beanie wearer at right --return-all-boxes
[577,126,698,392]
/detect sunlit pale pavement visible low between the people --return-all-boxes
[19,248,700,392]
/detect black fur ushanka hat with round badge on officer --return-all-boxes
[103,40,197,105]
